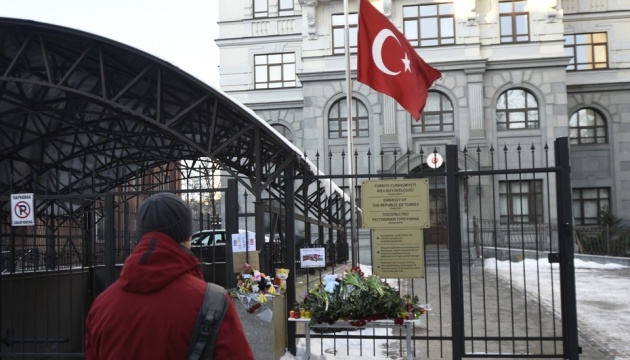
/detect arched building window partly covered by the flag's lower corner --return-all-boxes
[411,91,455,133]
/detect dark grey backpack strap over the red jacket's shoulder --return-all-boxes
[188,283,228,360]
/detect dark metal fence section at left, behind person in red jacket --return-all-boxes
[0,169,239,359]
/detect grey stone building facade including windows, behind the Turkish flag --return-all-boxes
[216,0,630,225]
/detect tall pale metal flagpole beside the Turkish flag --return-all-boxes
[343,0,359,266]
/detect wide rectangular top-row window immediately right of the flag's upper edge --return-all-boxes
[403,3,455,46]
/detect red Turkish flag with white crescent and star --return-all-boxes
[357,0,442,121]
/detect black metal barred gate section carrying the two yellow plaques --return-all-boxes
[289,138,579,359]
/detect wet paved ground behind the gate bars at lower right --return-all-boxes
[290,264,630,360]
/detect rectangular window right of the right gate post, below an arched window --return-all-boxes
[573,188,610,225]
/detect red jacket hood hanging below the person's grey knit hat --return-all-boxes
[120,232,203,293]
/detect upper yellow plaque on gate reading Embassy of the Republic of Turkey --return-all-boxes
[361,179,430,229]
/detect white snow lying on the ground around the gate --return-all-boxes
[280,259,630,360]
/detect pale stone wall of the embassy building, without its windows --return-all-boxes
[217,0,630,220]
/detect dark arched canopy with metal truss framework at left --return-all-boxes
[0,18,349,233]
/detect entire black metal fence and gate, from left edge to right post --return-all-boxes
[0,138,579,359]
